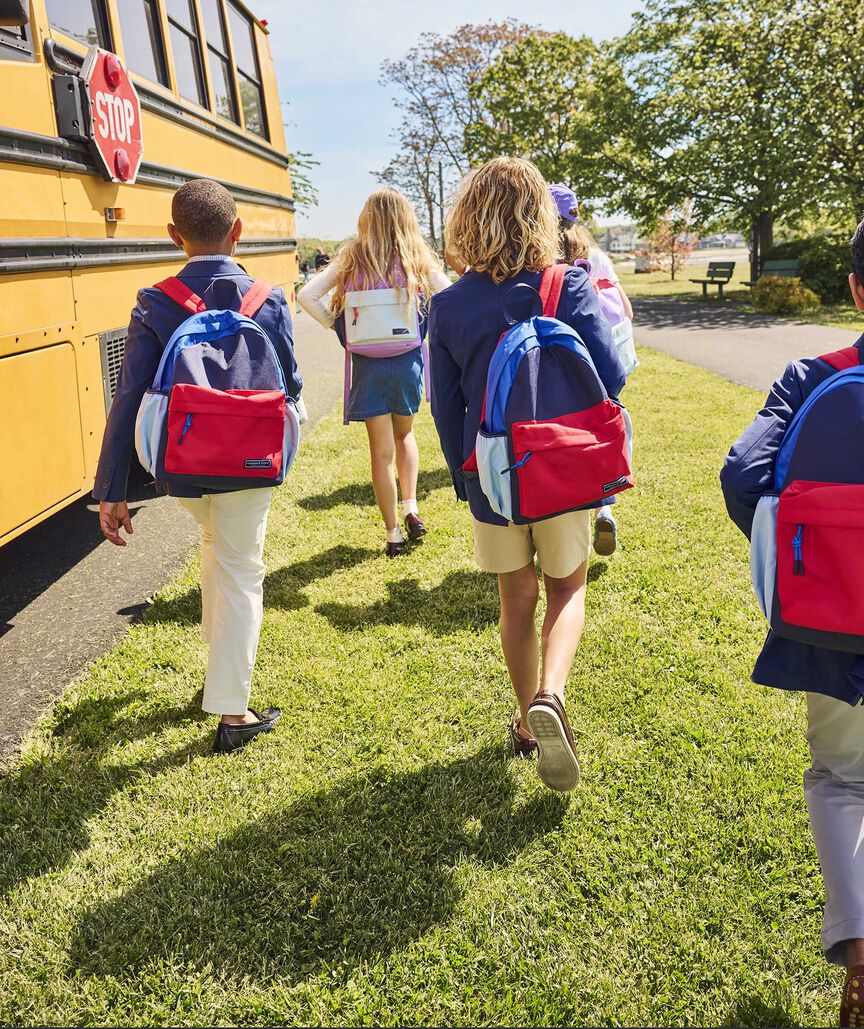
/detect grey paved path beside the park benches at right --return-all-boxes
[633,297,860,392]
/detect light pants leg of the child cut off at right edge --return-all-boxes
[804,694,864,965]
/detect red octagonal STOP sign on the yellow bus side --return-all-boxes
[81,46,144,183]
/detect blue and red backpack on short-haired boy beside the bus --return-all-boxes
[135,277,299,491]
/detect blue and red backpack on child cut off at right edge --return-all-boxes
[750,347,864,653]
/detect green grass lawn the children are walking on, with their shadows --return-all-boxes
[0,351,838,1026]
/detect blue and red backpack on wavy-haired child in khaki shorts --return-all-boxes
[462,264,633,525]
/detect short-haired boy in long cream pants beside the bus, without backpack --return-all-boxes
[93,179,302,753]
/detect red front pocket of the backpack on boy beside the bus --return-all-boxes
[165,383,286,478]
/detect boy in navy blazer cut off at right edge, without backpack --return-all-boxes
[720,221,864,1026]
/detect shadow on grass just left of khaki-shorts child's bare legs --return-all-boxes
[315,570,499,635]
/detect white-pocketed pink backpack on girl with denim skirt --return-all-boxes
[343,288,429,425]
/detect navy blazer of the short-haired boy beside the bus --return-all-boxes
[93,256,303,501]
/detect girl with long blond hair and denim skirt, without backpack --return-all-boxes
[297,188,449,558]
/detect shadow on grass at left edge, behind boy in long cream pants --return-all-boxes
[0,689,211,896]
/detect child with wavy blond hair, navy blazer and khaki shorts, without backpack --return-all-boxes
[429,157,624,790]
